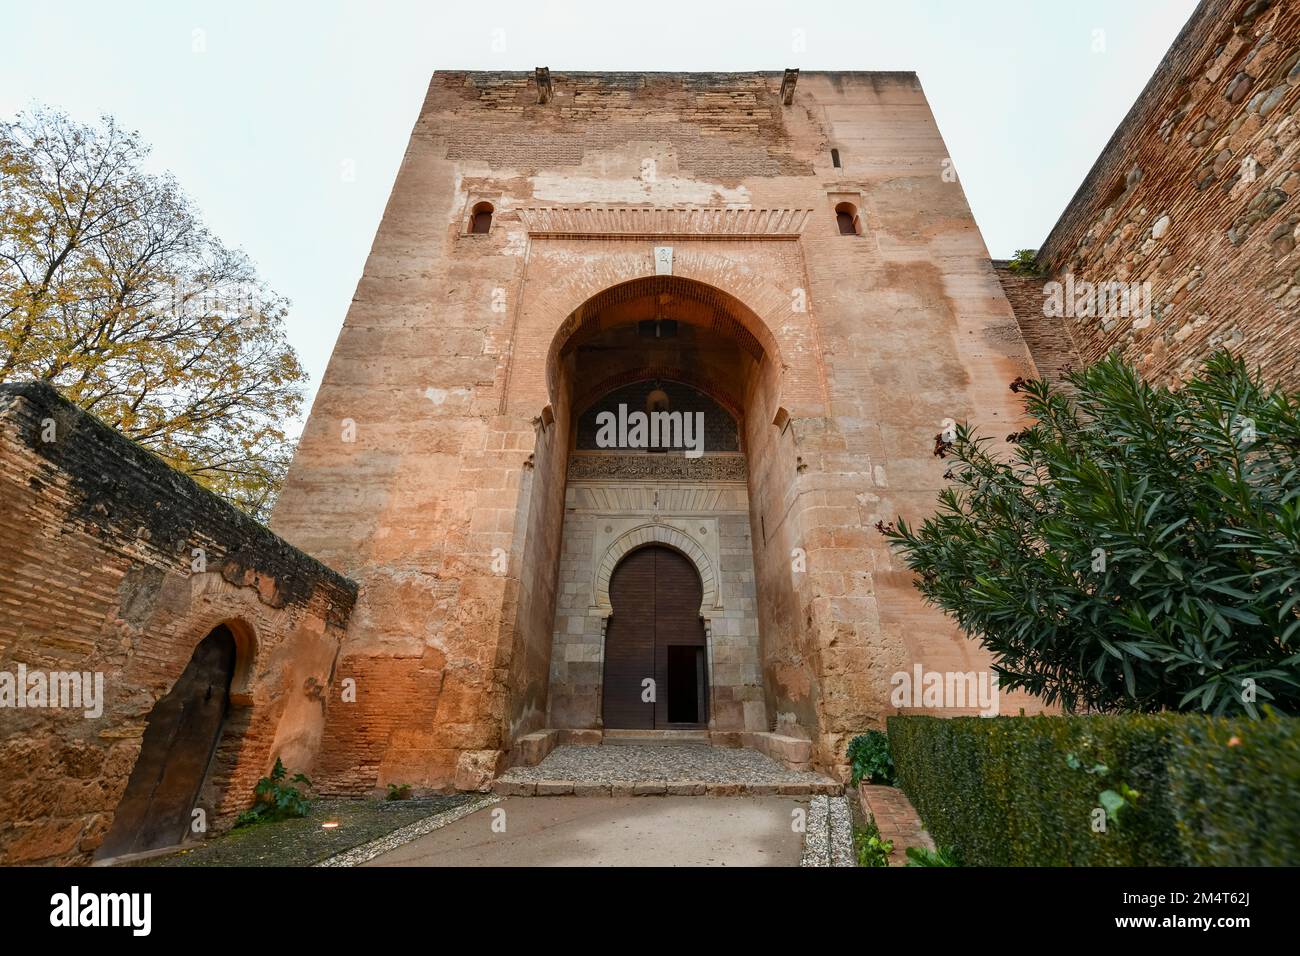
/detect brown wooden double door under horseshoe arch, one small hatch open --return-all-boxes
[602,545,709,730]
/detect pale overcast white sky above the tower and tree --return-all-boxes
[0,0,1196,421]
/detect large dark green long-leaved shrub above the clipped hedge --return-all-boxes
[879,352,1300,717]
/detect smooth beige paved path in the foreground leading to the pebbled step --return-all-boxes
[364,796,809,866]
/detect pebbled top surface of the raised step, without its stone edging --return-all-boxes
[501,744,829,784]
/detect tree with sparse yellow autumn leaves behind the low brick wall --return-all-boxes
[0,109,306,516]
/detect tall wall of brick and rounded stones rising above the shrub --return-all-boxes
[1039,0,1300,386]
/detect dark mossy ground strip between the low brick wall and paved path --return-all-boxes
[127,793,481,866]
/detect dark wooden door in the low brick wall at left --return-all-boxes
[98,626,235,858]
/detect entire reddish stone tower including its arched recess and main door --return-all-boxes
[272,69,1035,792]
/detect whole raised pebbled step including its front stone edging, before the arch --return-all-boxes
[493,743,841,797]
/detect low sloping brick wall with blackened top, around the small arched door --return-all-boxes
[0,385,355,864]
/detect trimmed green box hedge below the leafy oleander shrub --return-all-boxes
[889,714,1300,866]
